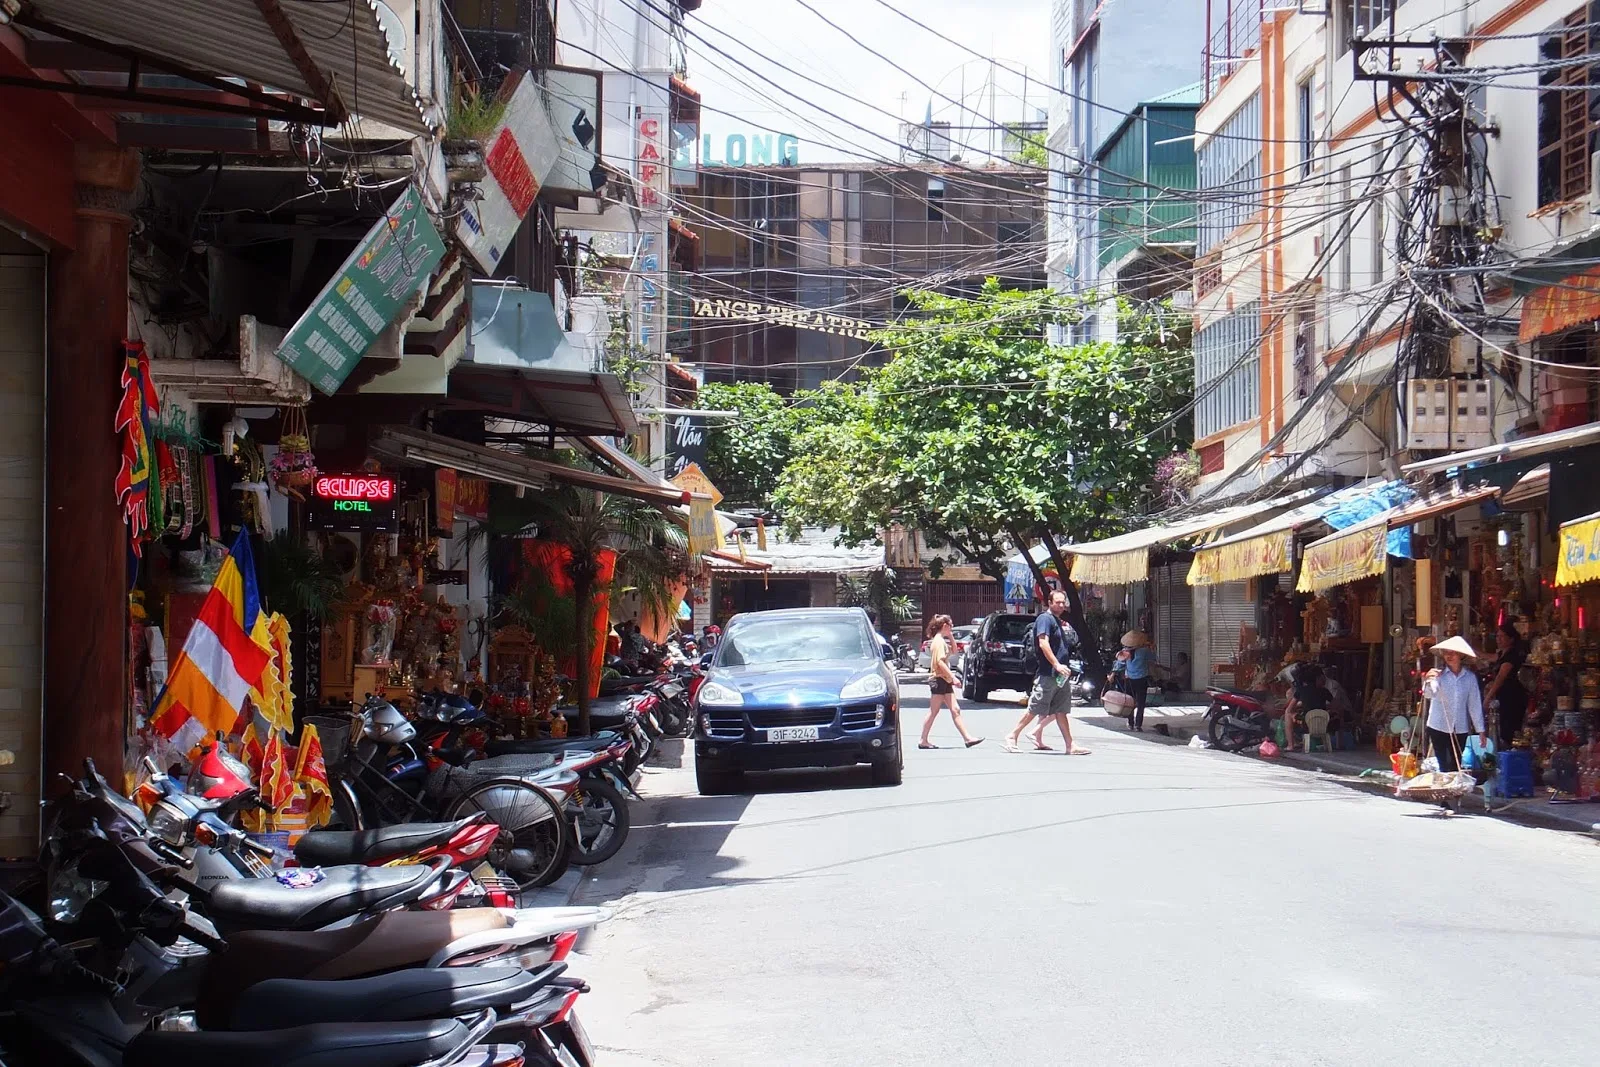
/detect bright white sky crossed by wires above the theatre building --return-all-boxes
[686,0,1054,163]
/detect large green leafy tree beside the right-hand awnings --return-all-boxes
[778,280,1190,668]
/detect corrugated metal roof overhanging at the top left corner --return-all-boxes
[32,0,429,133]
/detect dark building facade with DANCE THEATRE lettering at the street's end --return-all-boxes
[683,163,1045,392]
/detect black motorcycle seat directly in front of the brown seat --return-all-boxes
[229,963,566,1030]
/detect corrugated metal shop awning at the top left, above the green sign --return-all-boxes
[16,0,434,134]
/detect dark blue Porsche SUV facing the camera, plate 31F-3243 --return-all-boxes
[694,608,904,793]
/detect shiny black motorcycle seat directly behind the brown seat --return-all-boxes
[206,867,438,929]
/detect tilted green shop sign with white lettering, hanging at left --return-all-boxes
[277,186,445,397]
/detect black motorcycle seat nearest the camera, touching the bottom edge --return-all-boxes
[122,1019,469,1067]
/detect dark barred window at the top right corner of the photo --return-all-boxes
[1538,8,1600,208]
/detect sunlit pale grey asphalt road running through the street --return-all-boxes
[573,686,1600,1067]
